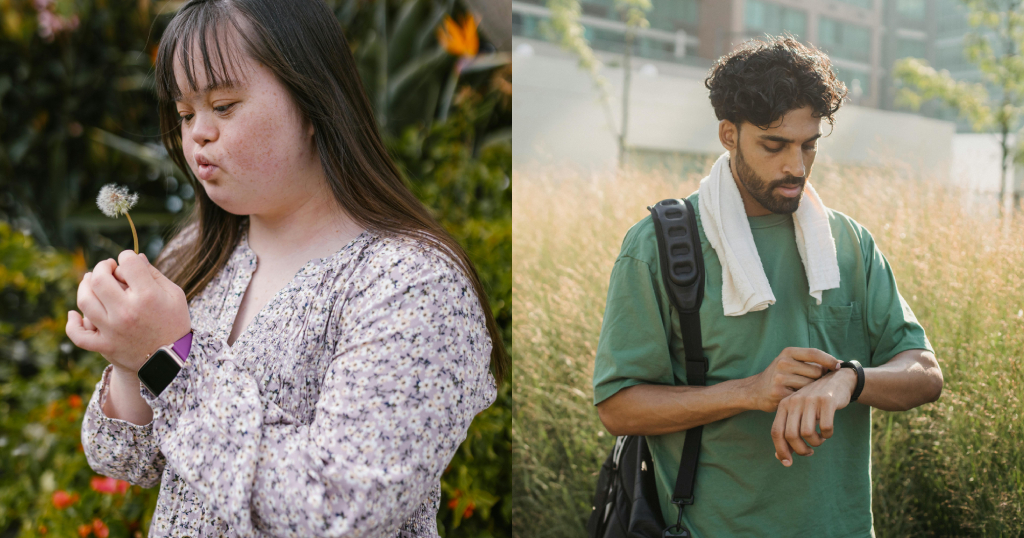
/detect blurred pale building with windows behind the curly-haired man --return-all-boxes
[512,0,1015,212]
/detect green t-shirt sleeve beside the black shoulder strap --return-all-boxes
[594,255,675,405]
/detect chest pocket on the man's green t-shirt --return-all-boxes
[807,302,870,366]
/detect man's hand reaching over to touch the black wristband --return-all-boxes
[748,347,849,414]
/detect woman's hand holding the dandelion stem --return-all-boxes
[66,250,191,374]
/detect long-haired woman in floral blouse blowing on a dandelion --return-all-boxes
[67,0,508,537]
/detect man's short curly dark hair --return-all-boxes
[705,35,847,129]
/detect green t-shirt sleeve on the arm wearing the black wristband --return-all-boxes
[861,224,934,366]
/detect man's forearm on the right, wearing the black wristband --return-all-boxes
[847,349,942,411]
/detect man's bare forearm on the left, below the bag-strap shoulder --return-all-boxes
[597,379,755,436]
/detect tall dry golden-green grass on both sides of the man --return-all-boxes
[512,161,1024,538]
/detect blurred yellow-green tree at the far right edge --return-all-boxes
[893,0,1024,216]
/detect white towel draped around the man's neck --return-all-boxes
[698,152,839,316]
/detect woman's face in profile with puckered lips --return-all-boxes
[174,37,325,219]
